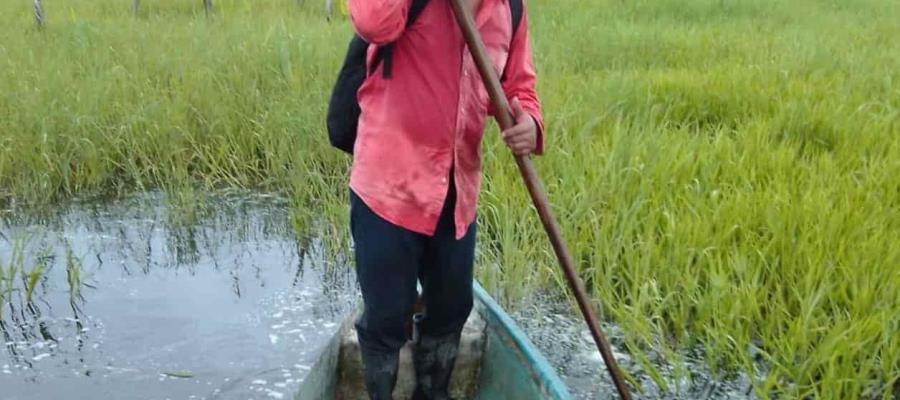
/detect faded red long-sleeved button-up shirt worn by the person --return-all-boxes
[349,0,543,238]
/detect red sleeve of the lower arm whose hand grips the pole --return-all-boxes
[502,10,544,155]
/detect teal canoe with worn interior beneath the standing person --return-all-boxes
[294,282,571,400]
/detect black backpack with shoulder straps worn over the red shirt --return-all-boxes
[326,0,523,154]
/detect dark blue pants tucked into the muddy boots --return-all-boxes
[350,184,476,354]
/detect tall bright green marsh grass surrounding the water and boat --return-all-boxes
[0,0,900,399]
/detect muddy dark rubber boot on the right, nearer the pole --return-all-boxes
[412,333,460,400]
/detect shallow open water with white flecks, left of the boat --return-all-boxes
[0,194,356,400]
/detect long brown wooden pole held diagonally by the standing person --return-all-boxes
[451,0,631,400]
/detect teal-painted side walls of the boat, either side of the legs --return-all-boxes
[294,283,571,400]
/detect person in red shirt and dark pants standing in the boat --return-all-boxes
[348,0,543,400]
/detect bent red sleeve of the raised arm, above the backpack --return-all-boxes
[347,0,412,45]
